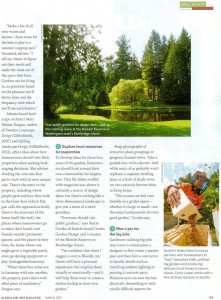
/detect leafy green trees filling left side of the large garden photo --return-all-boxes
[44,25,104,117]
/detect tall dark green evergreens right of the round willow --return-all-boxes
[141,29,191,104]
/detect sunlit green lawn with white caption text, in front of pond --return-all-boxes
[44,114,191,137]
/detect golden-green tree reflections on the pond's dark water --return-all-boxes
[110,110,190,122]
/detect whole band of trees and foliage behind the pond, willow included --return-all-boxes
[43,25,190,118]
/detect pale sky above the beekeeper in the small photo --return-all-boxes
[164,162,219,186]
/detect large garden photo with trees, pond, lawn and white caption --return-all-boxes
[43,25,191,137]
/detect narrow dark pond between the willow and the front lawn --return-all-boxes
[81,109,191,122]
